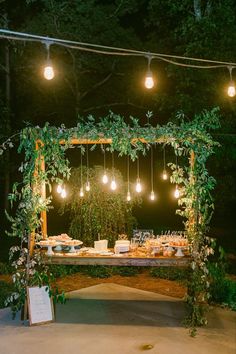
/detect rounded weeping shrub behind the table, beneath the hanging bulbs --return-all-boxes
[62,166,140,246]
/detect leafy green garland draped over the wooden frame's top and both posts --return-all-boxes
[1,108,219,329]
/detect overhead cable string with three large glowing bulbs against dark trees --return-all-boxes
[0,29,236,97]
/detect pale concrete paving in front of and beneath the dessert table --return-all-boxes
[0,284,236,354]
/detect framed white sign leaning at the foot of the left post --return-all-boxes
[27,286,54,326]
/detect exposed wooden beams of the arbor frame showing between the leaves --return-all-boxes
[36,137,195,242]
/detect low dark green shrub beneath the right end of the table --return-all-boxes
[150,267,191,282]
